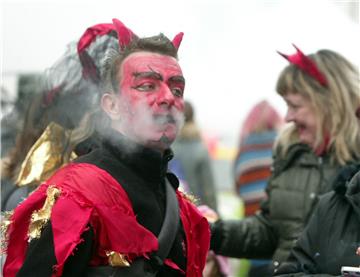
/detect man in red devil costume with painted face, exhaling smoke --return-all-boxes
[4,19,210,277]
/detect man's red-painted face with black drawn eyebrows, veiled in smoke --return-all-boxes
[119,52,185,149]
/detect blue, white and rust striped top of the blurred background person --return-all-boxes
[234,131,277,216]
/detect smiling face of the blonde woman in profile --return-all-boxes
[283,92,318,149]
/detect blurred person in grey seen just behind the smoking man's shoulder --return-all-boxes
[170,101,218,211]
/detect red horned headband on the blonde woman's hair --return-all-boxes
[277,44,327,87]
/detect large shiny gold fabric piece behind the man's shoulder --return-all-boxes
[16,122,70,186]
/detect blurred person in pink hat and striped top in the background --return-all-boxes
[234,100,283,277]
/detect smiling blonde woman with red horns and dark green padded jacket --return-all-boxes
[211,45,360,276]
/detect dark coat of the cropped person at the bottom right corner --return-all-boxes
[275,165,360,277]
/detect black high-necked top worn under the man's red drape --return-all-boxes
[16,132,186,277]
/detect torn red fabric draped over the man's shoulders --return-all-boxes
[4,164,210,277]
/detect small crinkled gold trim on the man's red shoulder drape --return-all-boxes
[28,186,61,241]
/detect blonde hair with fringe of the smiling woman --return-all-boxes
[276,50,360,164]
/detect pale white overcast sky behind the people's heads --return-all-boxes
[0,0,360,142]
